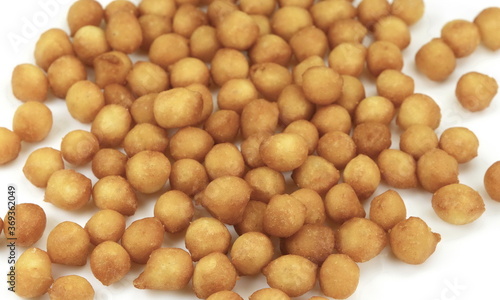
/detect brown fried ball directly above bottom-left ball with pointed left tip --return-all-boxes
[122,217,165,264]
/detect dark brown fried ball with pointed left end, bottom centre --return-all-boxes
[280,224,335,265]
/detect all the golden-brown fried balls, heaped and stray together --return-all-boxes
[0,0,500,300]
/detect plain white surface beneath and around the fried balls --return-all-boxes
[0,0,500,300]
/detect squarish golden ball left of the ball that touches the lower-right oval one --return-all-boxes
[377,149,418,189]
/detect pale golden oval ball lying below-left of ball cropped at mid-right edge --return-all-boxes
[432,183,485,225]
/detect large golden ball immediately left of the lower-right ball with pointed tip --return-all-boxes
[335,217,387,262]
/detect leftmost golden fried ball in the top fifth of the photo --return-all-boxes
[35,28,74,71]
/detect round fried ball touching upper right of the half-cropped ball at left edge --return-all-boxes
[12,101,52,142]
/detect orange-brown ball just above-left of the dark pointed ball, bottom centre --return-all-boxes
[262,194,307,238]
